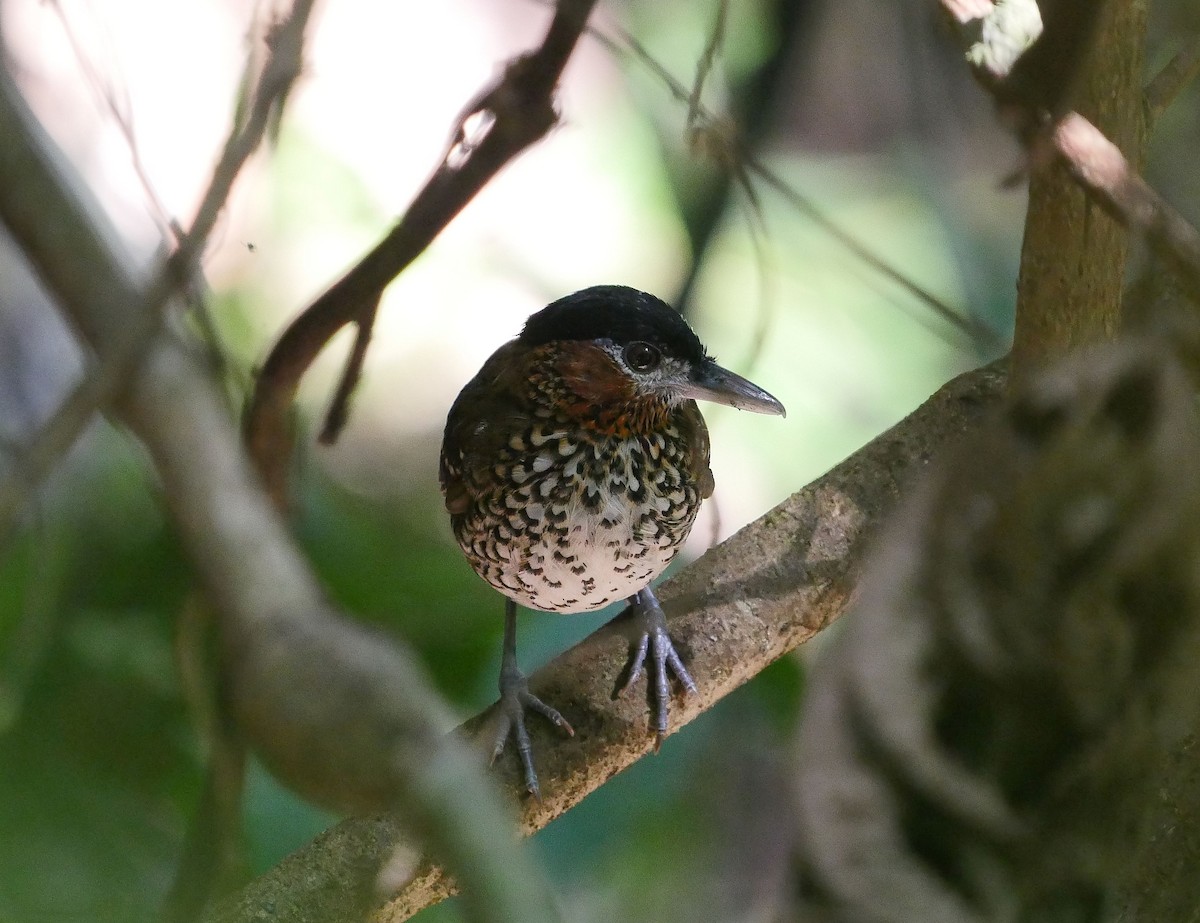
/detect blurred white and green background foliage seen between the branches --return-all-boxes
[0,0,1200,923]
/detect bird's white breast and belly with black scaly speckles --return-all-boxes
[451,418,701,612]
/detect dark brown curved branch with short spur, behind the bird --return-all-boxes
[245,0,595,508]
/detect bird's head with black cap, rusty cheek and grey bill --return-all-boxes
[518,286,785,416]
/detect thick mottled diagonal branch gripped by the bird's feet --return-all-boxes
[212,355,1004,923]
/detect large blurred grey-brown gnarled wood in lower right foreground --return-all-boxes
[791,331,1200,923]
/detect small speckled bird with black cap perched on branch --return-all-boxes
[439,284,785,798]
